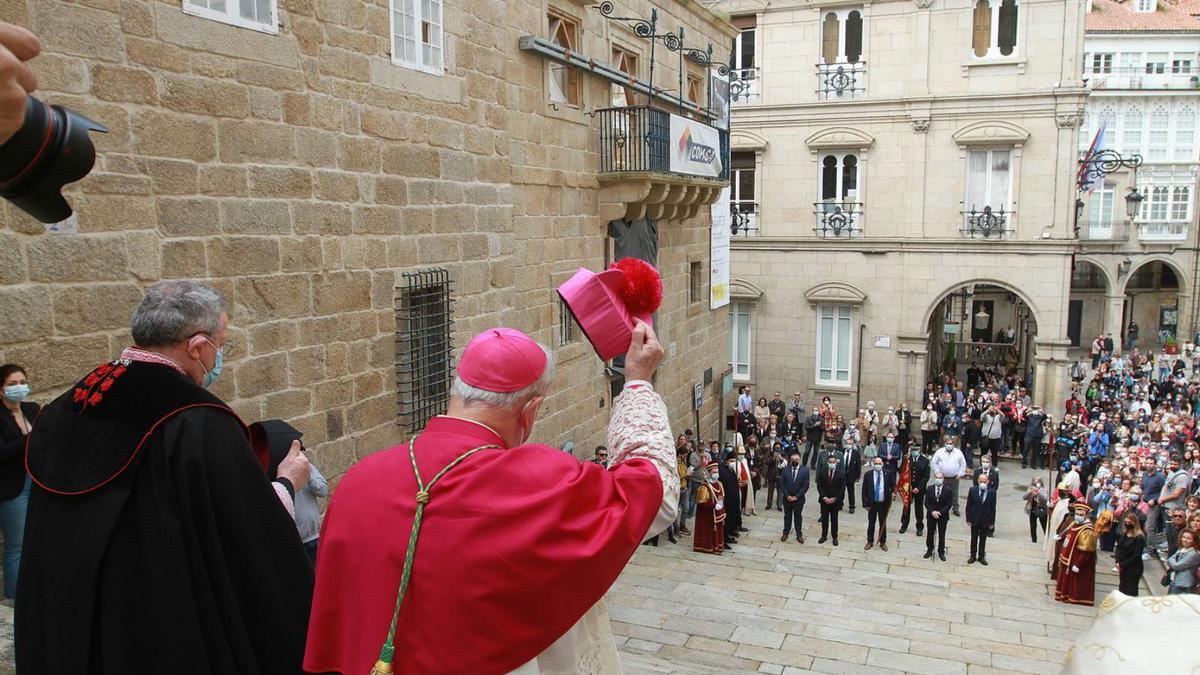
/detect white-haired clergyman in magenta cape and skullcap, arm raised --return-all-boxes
[305,321,679,675]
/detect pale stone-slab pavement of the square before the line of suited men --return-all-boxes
[606,465,1123,675]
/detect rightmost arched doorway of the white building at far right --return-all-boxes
[1121,259,1189,351]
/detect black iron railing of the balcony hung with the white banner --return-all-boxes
[595,106,730,180]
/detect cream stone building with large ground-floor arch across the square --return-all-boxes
[705,0,1087,414]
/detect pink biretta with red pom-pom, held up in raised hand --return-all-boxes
[558,258,662,360]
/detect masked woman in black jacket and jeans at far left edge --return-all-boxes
[0,364,34,604]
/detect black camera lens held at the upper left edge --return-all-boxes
[0,96,108,222]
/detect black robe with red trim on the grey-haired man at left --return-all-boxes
[16,362,312,675]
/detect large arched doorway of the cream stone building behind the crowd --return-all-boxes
[926,282,1037,396]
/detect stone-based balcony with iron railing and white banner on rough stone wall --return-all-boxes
[594,106,730,221]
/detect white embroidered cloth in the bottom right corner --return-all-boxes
[1062,591,1200,675]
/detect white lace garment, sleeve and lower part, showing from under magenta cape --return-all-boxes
[512,386,679,675]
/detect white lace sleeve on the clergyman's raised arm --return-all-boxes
[608,387,679,537]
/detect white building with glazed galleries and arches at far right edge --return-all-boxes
[1068,0,1200,351]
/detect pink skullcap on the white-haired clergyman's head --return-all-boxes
[458,328,546,394]
